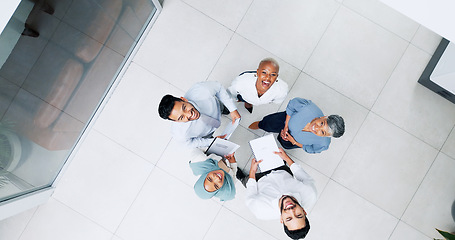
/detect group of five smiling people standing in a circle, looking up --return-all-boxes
[158,58,345,239]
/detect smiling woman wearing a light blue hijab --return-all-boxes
[190,153,237,201]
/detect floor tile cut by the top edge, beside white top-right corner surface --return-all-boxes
[343,0,419,41]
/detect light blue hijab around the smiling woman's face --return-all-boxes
[190,158,235,201]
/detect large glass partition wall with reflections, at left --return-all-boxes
[0,0,160,216]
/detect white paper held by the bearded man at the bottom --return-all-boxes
[250,134,284,172]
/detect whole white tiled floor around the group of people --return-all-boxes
[0,0,455,240]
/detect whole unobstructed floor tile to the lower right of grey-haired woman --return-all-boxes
[333,113,437,218]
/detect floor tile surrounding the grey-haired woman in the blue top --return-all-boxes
[280,74,368,177]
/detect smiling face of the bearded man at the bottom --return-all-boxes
[279,195,306,231]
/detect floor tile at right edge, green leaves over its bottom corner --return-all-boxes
[401,153,455,238]
